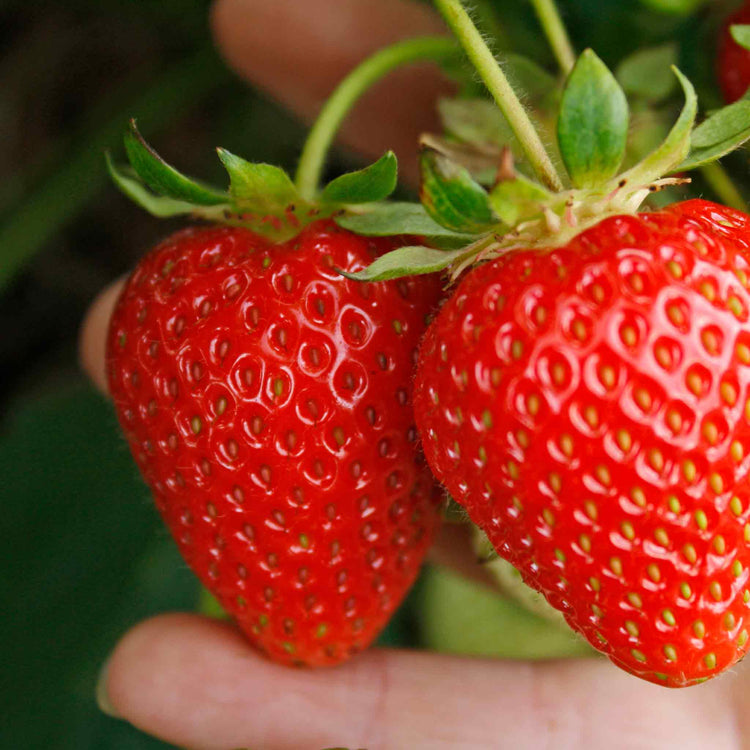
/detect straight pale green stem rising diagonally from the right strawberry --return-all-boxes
[435,0,563,191]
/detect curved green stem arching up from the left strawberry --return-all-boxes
[295,37,457,200]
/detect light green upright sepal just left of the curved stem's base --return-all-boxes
[217,148,301,215]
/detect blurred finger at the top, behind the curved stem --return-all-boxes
[213,0,451,177]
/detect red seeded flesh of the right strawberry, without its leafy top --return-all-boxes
[415,200,750,686]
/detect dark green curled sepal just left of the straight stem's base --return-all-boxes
[419,149,497,234]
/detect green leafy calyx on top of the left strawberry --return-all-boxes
[107,120,406,242]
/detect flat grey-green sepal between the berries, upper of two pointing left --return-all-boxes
[335,202,478,241]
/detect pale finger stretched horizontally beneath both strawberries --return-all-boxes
[104,615,739,750]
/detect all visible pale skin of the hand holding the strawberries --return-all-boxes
[81,0,750,750]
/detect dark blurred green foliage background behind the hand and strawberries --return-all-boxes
[0,0,740,750]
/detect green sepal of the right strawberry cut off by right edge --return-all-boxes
[672,99,750,172]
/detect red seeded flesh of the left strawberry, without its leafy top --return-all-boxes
[107,221,439,665]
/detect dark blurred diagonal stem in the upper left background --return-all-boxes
[0,48,230,292]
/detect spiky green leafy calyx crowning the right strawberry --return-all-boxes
[354,39,750,281]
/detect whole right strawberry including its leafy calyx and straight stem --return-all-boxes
[355,0,750,687]
